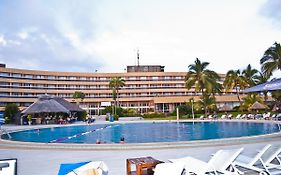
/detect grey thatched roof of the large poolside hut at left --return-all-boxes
[21,95,70,115]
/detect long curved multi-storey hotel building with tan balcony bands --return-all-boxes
[0,64,241,115]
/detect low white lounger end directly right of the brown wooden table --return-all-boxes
[154,162,185,175]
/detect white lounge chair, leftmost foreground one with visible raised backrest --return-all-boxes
[170,148,243,175]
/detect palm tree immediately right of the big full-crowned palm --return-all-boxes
[223,70,248,104]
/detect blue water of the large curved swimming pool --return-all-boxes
[3,122,278,143]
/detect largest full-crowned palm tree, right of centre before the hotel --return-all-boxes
[185,58,221,116]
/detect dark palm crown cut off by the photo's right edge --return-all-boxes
[260,42,281,76]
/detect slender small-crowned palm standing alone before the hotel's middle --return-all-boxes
[109,77,125,114]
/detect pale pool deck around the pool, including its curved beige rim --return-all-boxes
[0,120,281,175]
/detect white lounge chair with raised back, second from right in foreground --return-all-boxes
[234,144,271,173]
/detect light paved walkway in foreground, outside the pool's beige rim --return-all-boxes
[0,121,281,175]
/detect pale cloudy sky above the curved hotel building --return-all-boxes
[0,0,281,73]
